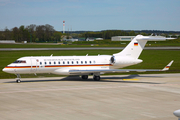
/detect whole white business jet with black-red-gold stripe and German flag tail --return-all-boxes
[3,35,173,83]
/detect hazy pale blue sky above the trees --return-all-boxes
[0,0,180,31]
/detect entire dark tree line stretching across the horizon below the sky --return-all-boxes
[0,24,180,42]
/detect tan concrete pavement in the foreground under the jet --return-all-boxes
[0,74,180,120]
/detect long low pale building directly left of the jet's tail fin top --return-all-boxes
[111,36,135,41]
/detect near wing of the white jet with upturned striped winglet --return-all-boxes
[69,60,174,74]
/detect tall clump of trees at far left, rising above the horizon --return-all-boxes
[0,24,62,42]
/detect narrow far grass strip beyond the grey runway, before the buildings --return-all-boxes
[0,39,180,48]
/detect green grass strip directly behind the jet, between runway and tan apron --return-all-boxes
[0,50,180,79]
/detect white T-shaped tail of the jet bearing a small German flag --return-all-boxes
[113,35,174,59]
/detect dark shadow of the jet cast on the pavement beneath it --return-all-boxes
[5,74,162,84]
